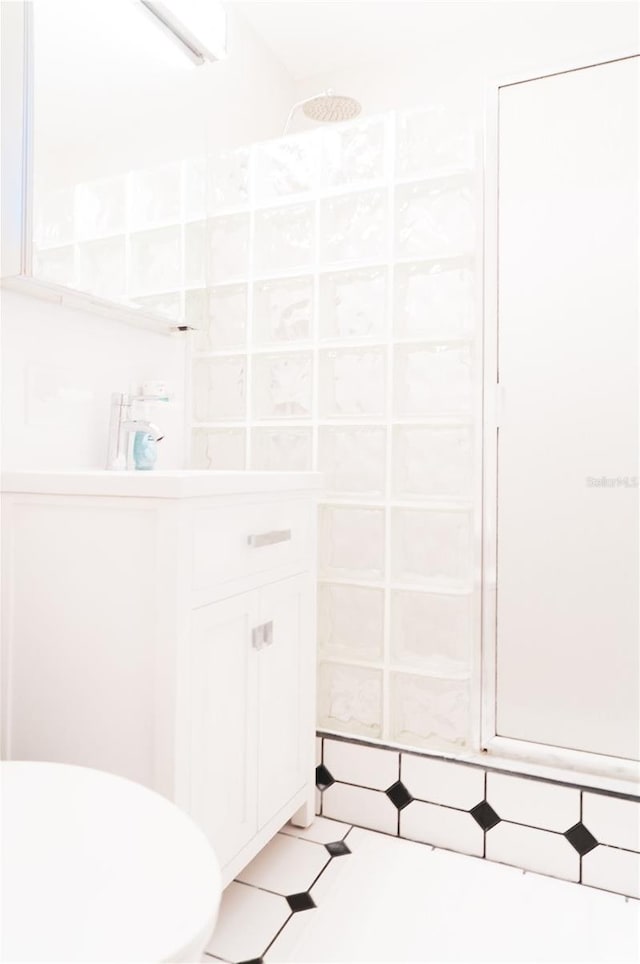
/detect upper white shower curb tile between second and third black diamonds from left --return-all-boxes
[400,753,484,810]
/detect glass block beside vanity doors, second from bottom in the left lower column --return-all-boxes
[318,583,384,662]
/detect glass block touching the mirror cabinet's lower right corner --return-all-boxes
[185,285,247,351]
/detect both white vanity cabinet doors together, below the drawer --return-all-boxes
[186,575,312,864]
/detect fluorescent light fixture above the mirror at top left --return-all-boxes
[140,0,227,64]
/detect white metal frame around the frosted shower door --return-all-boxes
[479,49,640,792]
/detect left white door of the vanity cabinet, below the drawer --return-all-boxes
[188,593,258,867]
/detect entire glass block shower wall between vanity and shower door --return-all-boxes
[192,109,480,752]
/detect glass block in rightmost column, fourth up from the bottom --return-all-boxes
[392,425,473,499]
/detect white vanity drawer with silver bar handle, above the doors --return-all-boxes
[192,499,311,591]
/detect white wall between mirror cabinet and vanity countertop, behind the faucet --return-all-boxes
[1,291,185,470]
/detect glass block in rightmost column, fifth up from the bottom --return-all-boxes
[394,344,473,416]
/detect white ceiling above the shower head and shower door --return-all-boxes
[230,0,637,80]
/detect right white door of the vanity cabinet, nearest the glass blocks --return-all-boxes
[258,575,315,826]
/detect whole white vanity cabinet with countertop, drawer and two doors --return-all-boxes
[2,472,319,882]
